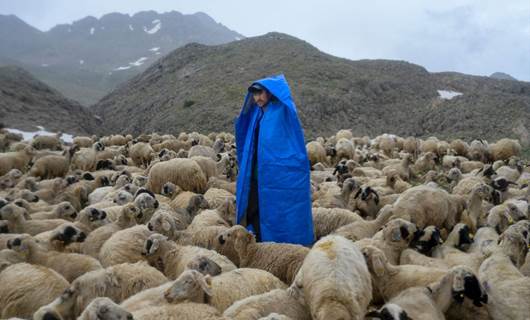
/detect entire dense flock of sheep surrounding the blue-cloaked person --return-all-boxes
[0,130,530,320]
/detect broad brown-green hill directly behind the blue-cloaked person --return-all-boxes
[93,33,530,139]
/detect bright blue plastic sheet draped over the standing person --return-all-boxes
[235,75,314,245]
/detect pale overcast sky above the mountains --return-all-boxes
[0,0,530,81]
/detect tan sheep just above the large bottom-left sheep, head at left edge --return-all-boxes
[7,235,102,282]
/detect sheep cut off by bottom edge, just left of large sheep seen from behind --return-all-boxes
[223,285,311,320]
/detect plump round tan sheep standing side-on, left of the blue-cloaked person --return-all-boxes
[147,158,208,193]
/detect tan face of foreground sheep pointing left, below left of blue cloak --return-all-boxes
[164,270,212,303]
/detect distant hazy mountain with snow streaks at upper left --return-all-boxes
[0,11,243,105]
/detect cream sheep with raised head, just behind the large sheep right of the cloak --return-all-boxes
[333,205,393,241]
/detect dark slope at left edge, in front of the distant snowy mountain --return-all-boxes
[0,66,99,134]
